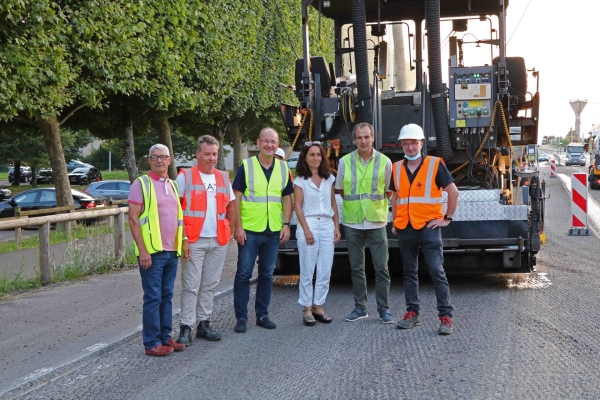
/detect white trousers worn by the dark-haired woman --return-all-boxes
[296,217,335,307]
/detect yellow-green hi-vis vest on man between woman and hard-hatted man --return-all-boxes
[342,150,389,223]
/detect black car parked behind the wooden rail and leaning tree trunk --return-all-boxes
[0,188,105,218]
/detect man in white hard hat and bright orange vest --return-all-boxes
[390,124,458,335]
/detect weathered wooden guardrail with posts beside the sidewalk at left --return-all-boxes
[0,205,129,286]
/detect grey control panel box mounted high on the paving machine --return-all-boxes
[449,66,494,128]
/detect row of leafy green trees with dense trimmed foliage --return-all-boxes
[0,0,333,209]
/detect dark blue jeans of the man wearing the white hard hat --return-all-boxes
[396,224,454,318]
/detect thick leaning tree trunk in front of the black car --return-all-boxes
[36,117,73,207]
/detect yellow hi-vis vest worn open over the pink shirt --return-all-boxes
[135,175,183,256]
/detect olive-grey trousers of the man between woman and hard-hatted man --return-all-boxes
[344,226,390,311]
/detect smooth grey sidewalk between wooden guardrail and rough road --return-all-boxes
[0,236,248,397]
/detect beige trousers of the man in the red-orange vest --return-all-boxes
[179,238,227,326]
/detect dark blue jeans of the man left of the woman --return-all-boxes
[233,231,279,321]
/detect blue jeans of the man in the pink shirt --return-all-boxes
[138,251,179,350]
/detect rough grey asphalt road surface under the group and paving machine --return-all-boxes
[0,161,600,399]
